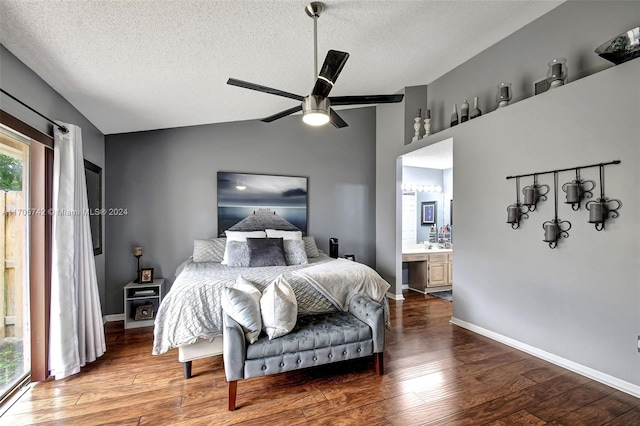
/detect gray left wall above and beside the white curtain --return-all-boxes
[0,45,106,311]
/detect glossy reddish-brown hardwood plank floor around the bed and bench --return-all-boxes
[0,292,640,426]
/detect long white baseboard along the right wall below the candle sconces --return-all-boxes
[451,317,640,398]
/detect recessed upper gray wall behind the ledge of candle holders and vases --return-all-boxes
[422,0,640,133]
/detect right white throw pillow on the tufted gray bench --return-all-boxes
[260,275,298,340]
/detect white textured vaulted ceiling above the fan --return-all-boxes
[0,0,561,134]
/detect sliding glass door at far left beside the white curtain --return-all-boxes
[0,126,30,400]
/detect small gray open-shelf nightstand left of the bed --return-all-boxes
[124,278,164,329]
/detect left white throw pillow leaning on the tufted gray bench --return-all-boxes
[220,277,262,343]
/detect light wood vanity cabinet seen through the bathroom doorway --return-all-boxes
[402,252,453,293]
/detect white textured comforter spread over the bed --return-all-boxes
[152,255,390,355]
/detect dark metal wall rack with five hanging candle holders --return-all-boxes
[507,160,622,249]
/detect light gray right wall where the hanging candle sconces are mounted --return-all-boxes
[453,60,640,392]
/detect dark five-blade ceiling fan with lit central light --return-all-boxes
[227,2,404,128]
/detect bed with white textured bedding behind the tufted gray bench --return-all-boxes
[152,237,390,378]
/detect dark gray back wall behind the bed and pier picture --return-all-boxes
[106,108,375,314]
